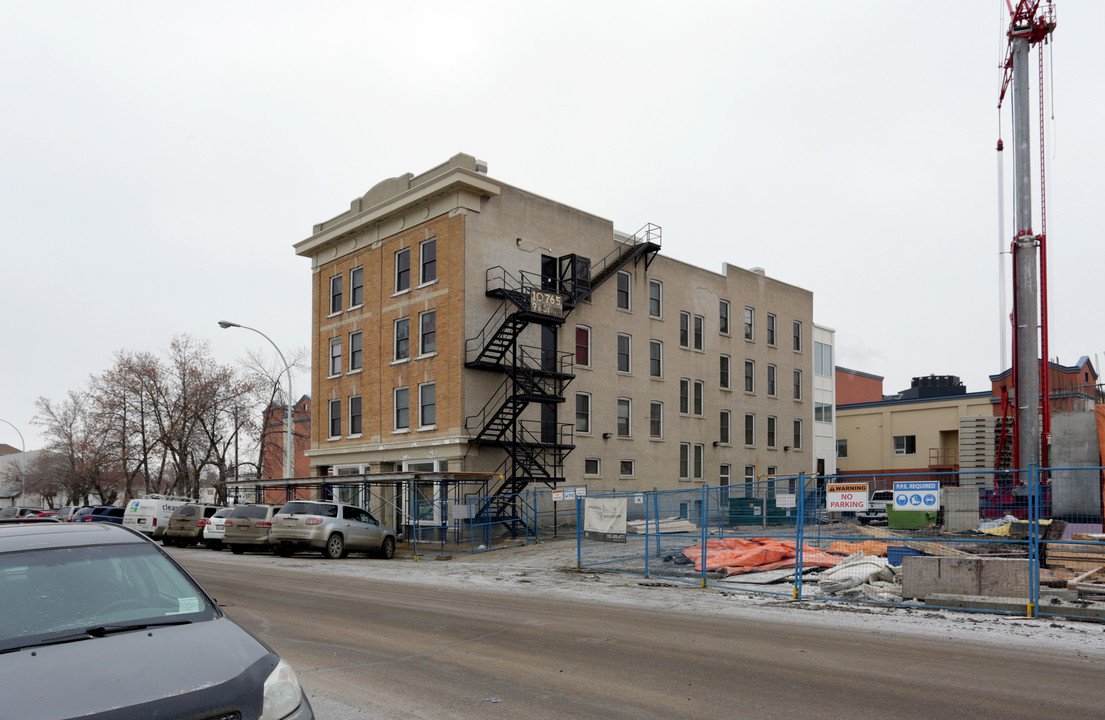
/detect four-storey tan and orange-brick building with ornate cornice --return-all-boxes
[295,155,833,501]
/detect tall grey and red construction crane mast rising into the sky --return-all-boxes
[998,0,1055,483]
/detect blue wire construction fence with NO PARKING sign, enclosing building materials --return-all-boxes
[576,467,1105,620]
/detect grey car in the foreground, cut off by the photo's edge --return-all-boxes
[0,520,314,720]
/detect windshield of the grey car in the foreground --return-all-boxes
[0,542,218,653]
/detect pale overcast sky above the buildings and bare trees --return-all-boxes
[0,0,1105,448]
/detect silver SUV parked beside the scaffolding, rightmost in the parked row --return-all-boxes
[269,500,396,560]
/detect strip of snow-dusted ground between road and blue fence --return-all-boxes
[185,540,1105,661]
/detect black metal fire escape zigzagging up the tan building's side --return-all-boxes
[465,224,661,533]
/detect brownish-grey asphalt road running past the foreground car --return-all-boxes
[178,552,1105,720]
